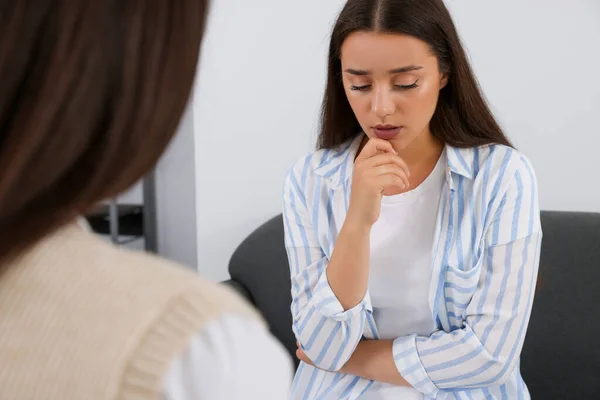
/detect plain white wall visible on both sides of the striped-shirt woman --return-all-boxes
[179,0,600,280]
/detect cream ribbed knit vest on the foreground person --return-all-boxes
[0,224,258,400]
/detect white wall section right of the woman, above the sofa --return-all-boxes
[447,0,600,211]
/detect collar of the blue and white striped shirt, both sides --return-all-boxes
[315,134,478,187]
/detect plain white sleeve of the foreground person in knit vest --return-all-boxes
[163,315,292,400]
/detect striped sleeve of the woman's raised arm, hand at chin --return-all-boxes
[283,160,372,371]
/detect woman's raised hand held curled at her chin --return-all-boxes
[346,138,410,227]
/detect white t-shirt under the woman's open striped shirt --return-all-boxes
[365,152,446,400]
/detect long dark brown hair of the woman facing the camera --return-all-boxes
[317,0,511,148]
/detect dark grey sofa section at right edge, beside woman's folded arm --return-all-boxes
[521,212,600,399]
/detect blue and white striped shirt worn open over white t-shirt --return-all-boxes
[283,135,542,400]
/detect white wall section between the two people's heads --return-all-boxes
[194,0,343,280]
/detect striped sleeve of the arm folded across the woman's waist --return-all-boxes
[393,155,542,398]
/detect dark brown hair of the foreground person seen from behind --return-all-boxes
[0,0,207,260]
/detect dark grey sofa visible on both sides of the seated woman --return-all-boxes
[226,211,600,400]
